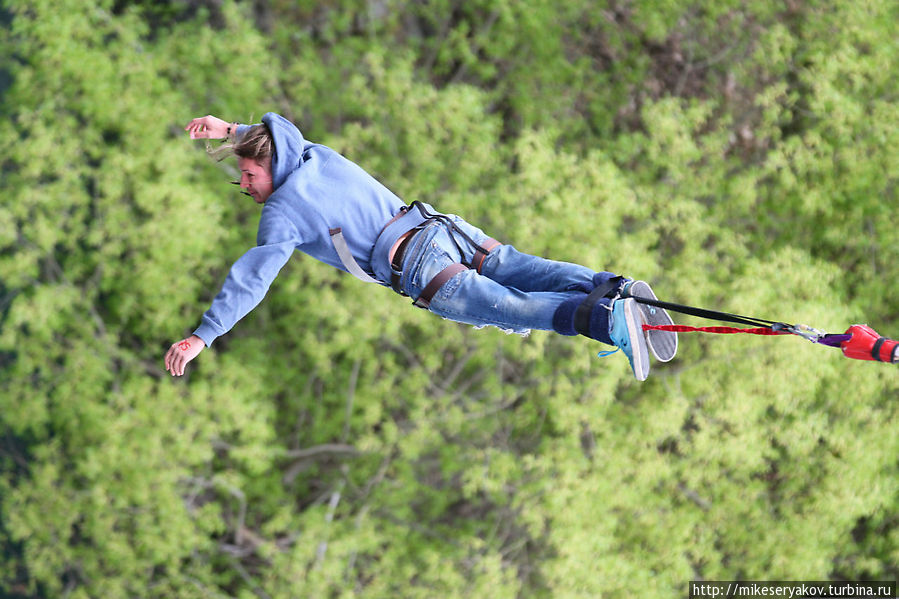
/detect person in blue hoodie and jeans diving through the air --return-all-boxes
[165,113,677,381]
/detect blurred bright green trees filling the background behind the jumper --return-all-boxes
[0,0,899,597]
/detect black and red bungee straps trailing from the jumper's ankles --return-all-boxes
[619,290,899,363]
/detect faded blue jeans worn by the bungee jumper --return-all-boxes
[400,215,596,334]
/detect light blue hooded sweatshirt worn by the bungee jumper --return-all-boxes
[194,112,408,347]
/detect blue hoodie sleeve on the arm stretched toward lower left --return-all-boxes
[194,206,301,347]
